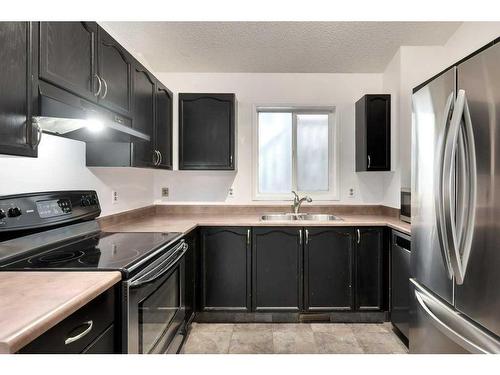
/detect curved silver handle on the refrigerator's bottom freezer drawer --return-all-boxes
[410,279,500,354]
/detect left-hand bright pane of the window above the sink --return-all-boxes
[259,112,292,194]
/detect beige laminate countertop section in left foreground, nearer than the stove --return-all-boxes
[0,271,121,353]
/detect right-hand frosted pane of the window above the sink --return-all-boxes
[297,115,328,192]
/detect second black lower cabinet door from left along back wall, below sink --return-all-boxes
[252,227,303,312]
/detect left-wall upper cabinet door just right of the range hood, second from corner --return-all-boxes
[132,67,155,167]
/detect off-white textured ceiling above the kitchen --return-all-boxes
[103,22,460,73]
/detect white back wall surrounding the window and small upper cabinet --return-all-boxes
[155,73,390,204]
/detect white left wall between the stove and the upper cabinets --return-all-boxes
[0,134,153,216]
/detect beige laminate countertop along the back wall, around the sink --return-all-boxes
[103,214,411,234]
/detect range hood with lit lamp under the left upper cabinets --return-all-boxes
[33,81,151,143]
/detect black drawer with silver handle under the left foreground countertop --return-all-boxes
[19,288,116,354]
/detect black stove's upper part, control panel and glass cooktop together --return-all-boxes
[0,191,181,278]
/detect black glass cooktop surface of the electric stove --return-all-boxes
[0,232,181,271]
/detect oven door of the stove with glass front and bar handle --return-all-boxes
[123,240,188,354]
